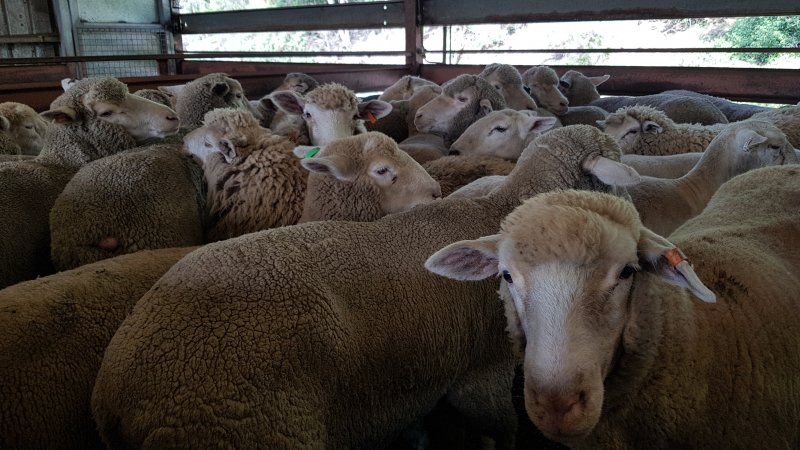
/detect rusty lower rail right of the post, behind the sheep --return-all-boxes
[421,65,800,103]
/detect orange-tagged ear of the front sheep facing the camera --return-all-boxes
[637,228,717,303]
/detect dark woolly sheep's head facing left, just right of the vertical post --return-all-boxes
[414,75,506,147]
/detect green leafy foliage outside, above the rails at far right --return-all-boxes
[722,16,800,65]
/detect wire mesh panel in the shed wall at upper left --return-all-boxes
[76,25,168,77]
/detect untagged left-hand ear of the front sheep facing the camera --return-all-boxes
[425,234,500,280]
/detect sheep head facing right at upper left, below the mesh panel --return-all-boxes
[41,77,180,142]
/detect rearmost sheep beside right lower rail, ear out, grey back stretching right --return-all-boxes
[561,70,729,125]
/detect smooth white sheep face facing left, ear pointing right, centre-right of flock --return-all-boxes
[450,109,556,161]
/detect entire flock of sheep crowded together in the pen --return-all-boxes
[0,64,800,450]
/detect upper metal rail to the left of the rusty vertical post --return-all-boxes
[176,0,404,34]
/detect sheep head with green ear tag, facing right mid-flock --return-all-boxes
[295,132,442,215]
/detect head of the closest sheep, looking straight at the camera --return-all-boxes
[426,191,714,445]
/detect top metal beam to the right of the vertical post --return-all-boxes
[422,0,800,25]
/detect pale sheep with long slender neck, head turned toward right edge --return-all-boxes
[628,119,800,236]
